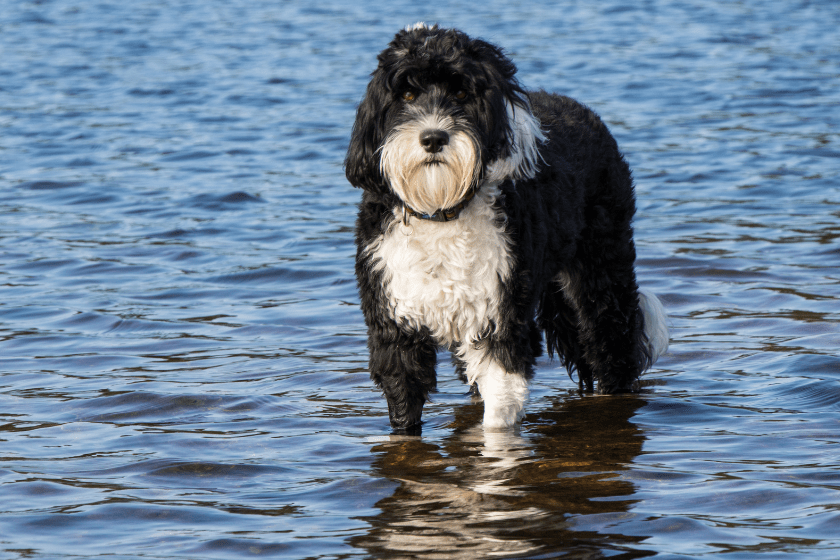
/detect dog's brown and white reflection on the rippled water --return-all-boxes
[351,395,650,560]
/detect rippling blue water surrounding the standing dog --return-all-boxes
[0,0,840,559]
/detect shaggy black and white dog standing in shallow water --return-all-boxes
[345,24,668,431]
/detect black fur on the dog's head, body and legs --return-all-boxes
[345,27,651,430]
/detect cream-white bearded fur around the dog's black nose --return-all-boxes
[380,109,481,214]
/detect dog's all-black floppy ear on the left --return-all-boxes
[344,71,391,194]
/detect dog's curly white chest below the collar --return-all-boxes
[369,195,511,345]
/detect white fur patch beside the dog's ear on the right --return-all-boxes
[487,98,545,181]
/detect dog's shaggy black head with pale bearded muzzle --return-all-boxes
[345,24,543,214]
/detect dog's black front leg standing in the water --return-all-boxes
[368,333,437,433]
